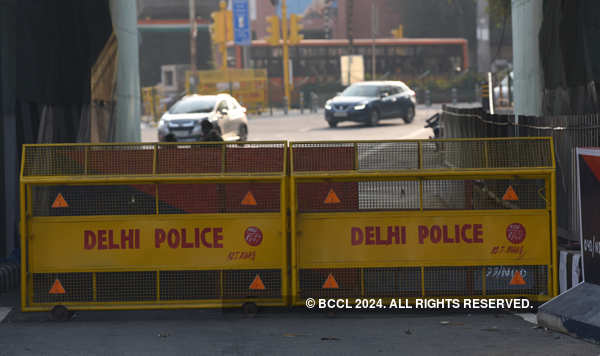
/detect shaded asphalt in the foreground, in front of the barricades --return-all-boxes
[0,294,600,356]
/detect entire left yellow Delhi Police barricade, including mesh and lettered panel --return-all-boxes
[21,142,288,311]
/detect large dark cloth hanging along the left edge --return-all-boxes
[0,0,112,260]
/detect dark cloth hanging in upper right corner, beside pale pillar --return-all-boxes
[539,0,600,115]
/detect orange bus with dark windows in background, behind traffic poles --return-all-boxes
[228,38,469,103]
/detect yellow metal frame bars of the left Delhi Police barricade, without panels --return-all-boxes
[20,141,289,311]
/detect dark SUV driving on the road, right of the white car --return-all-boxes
[325,81,417,127]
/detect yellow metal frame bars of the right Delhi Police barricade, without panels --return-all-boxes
[289,137,558,305]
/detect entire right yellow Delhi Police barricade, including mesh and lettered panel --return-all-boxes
[290,138,558,304]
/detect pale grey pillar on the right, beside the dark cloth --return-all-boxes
[512,0,544,116]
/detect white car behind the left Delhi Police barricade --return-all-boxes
[158,94,248,142]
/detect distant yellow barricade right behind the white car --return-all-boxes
[186,68,268,113]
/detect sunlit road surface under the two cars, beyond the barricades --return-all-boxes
[142,105,440,142]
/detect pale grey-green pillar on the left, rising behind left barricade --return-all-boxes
[110,0,141,142]
